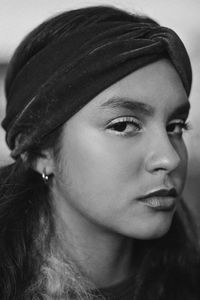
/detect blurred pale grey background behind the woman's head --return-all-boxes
[0,0,200,233]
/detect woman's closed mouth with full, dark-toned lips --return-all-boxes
[138,188,178,211]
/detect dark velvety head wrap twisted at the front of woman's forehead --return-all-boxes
[2,8,192,157]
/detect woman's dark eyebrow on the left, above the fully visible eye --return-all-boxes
[100,97,155,116]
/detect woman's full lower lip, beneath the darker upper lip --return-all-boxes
[140,197,176,211]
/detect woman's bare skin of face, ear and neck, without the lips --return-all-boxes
[37,59,189,286]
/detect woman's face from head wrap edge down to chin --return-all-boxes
[53,59,189,239]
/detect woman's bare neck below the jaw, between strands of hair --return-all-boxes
[51,191,134,288]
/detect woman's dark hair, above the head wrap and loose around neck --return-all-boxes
[0,6,200,300]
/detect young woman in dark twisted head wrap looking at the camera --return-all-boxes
[0,7,199,300]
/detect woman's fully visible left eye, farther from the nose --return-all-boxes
[107,117,142,136]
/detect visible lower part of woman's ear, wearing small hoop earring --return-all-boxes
[33,149,54,175]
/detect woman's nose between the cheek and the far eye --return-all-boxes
[145,132,181,173]
